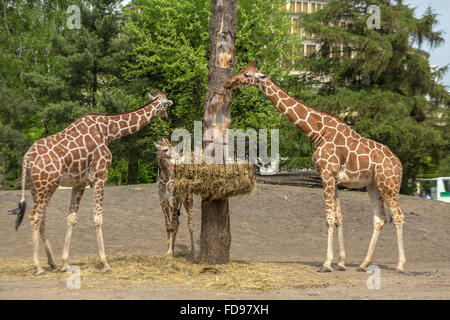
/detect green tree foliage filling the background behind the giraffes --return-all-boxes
[0,0,450,192]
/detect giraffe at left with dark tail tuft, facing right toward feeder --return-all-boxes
[11,91,173,275]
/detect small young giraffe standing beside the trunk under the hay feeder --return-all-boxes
[155,138,195,257]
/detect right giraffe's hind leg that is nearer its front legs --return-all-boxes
[359,185,386,271]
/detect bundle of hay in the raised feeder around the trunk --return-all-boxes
[174,154,256,201]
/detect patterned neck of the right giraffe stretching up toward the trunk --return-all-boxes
[259,79,323,146]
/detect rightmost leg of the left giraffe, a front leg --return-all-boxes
[94,173,111,272]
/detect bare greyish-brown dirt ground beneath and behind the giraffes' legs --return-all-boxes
[0,184,450,299]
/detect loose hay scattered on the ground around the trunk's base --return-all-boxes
[0,252,356,292]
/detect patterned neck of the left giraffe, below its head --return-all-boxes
[105,101,159,142]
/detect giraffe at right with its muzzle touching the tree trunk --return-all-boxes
[224,61,406,272]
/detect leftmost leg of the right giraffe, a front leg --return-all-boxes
[317,173,336,272]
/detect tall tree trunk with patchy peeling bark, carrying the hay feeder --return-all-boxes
[200,0,237,264]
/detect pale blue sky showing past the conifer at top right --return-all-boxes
[122,0,450,90]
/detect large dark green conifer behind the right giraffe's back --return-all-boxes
[287,0,450,193]
